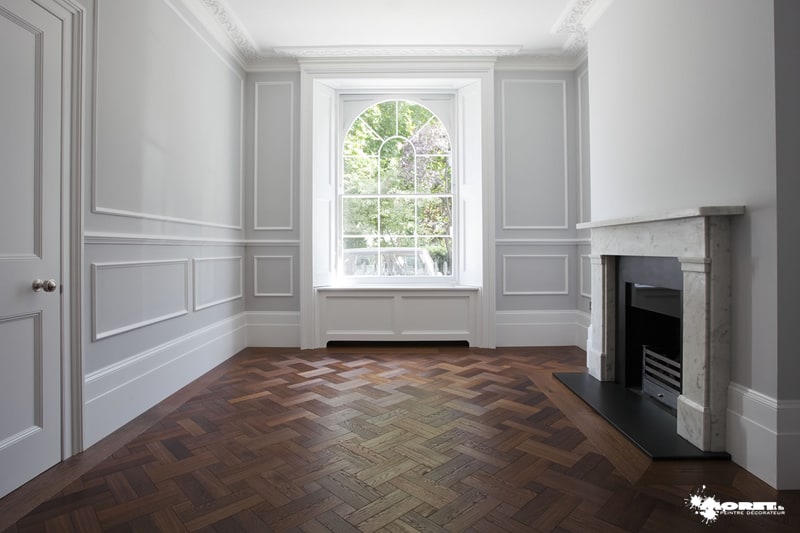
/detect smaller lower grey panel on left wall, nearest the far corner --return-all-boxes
[194,256,243,311]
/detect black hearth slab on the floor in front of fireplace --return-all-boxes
[554,372,731,460]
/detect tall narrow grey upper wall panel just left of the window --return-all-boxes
[254,81,294,230]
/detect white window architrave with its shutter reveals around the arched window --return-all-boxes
[299,60,495,348]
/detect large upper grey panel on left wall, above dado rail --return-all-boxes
[92,0,244,229]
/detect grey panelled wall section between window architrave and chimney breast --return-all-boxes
[495,67,590,311]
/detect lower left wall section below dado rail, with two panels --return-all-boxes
[84,243,245,375]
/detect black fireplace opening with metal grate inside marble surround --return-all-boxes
[615,256,683,411]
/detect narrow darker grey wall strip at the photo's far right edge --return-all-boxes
[775,0,800,400]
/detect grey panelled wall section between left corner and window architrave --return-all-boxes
[245,71,300,312]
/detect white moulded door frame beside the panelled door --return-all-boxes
[45,0,88,461]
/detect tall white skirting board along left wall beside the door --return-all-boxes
[83,313,247,448]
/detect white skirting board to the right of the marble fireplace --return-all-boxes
[725,383,800,490]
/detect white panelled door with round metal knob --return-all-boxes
[0,0,62,497]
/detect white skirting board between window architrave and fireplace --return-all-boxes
[496,310,591,350]
